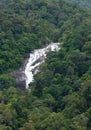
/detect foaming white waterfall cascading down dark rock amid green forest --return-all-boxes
[25,43,60,88]
